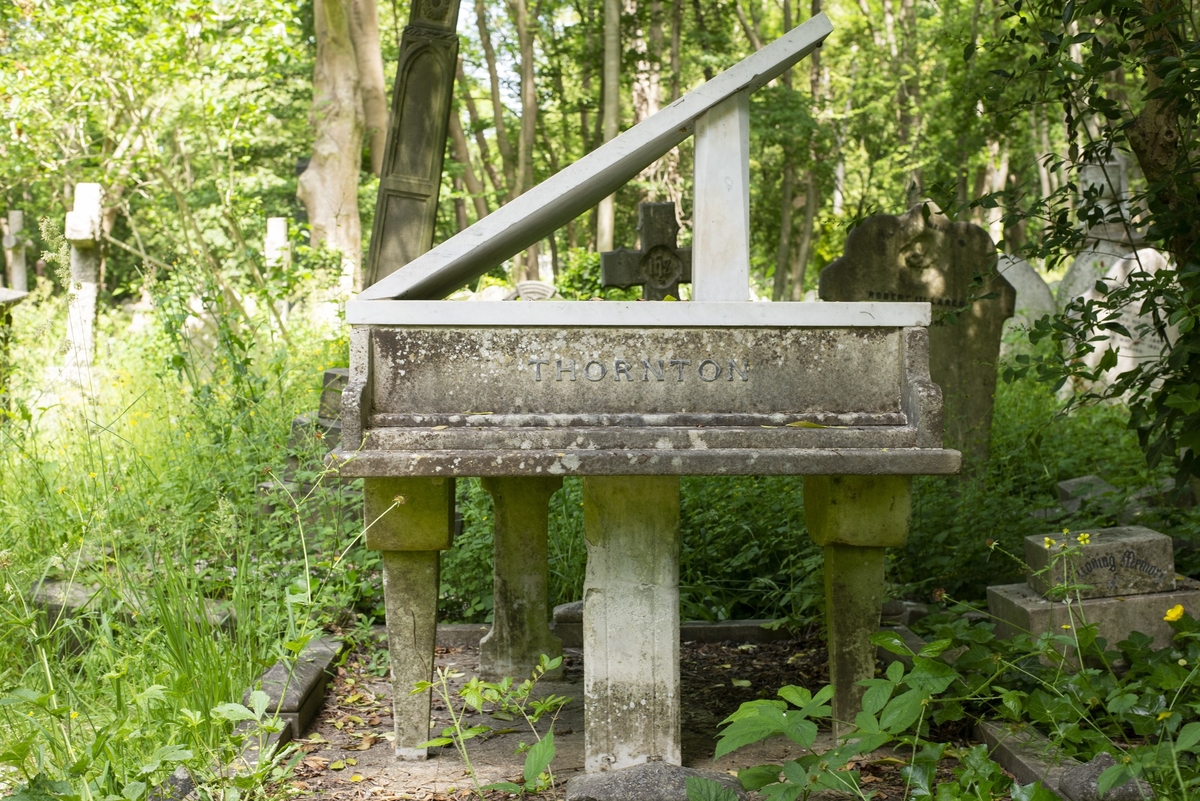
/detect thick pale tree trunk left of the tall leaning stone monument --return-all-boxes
[296,0,362,295]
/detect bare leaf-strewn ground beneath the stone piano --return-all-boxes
[289,630,1007,801]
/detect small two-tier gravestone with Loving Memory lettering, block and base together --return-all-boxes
[988,526,1200,656]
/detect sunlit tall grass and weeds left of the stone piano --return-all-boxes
[0,284,360,801]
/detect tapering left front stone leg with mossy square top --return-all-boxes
[362,477,454,759]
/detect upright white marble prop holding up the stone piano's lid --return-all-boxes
[691,89,750,301]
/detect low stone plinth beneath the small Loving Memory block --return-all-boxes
[988,579,1200,648]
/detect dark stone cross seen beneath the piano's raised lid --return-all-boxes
[600,203,691,300]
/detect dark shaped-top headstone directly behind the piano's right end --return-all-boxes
[820,206,1016,470]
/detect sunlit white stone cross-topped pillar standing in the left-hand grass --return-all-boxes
[64,183,102,371]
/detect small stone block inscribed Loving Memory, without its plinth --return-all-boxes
[1025,525,1175,598]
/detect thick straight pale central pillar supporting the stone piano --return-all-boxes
[583,476,679,773]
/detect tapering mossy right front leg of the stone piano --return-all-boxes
[804,476,912,735]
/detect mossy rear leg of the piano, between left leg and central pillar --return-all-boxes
[479,476,563,680]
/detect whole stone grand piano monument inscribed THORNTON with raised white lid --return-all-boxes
[334,14,960,772]
